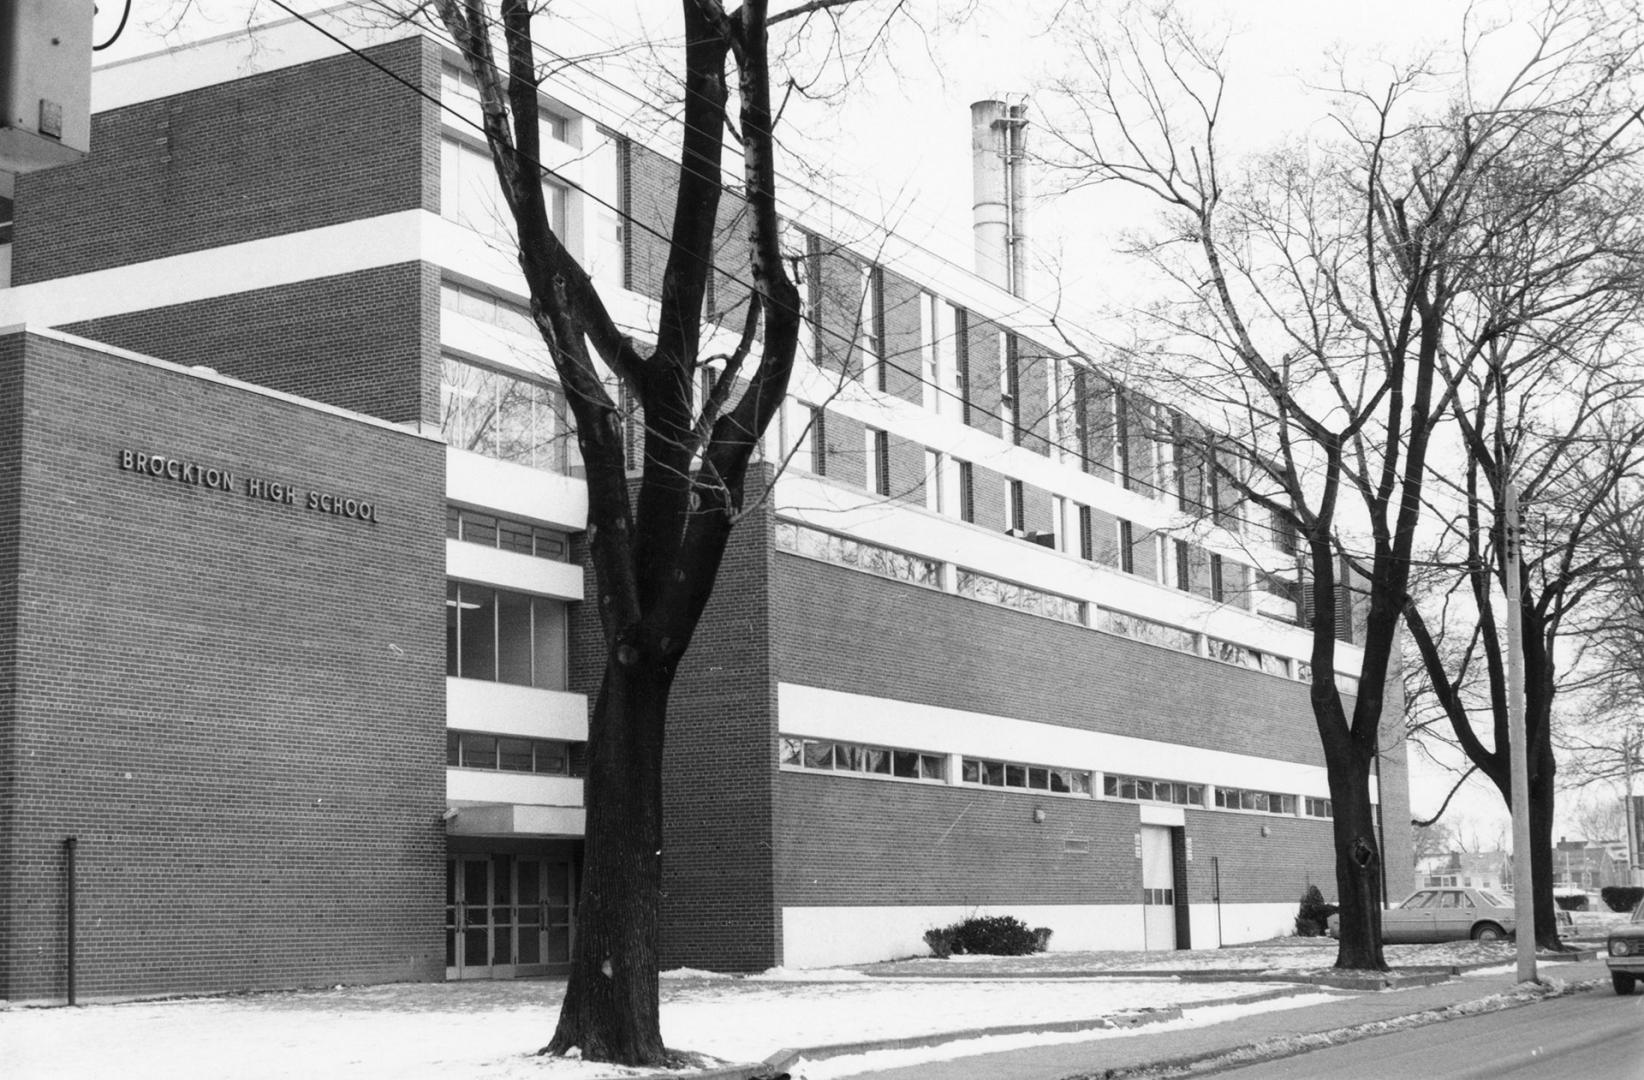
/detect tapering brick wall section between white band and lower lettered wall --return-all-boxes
[62,263,439,424]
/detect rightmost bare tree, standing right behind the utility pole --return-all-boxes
[1406,338,1644,947]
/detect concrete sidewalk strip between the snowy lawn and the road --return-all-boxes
[769,960,1609,1080]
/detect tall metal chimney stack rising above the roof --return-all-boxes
[970,97,1028,298]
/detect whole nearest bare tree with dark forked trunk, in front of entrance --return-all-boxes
[409,0,896,1065]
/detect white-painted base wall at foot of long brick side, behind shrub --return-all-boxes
[783,904,1295,968]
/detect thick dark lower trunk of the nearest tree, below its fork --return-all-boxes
[543,657,674,1065]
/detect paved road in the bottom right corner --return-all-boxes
[1215,988,1644,1080]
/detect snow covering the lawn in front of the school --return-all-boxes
[0,940,1514,1080]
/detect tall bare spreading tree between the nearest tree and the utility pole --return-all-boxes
[1039,3,1634,968]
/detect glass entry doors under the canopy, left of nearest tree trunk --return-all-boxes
[446,853,574,978]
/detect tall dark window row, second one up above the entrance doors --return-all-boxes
[446,582,567,690]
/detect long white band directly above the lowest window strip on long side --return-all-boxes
[776,682,1379,798]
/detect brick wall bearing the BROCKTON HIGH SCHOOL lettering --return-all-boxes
[0,335,446,999]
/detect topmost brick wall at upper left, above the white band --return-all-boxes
[12,38,439,284]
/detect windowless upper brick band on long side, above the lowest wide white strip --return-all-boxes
[773,554,1323,766]
